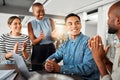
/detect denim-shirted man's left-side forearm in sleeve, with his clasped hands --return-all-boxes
[44,43,66,72]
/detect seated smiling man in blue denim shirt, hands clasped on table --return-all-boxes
[45,13,99,80]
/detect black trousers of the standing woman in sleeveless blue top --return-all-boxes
[31,43,55,71]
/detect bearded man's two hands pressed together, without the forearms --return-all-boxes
[88,35,110,60]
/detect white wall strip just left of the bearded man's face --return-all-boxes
[97,5,109,45]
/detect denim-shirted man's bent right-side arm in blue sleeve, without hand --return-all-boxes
[60,43,97,76]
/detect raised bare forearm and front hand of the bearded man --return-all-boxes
[89,36,108,77]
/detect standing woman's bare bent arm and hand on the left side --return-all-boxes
[28,22,44,45]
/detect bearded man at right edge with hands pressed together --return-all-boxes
[89,1,120,80]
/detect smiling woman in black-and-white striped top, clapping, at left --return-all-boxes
[0,16,31,64]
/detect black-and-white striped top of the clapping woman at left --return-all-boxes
[0,33,31,64]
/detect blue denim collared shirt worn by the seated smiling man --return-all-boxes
[48,33,100,80]
